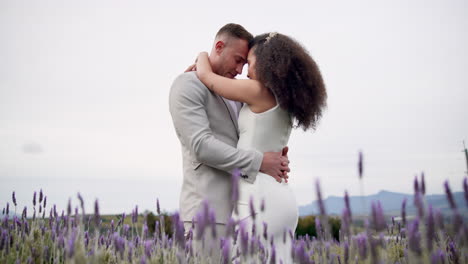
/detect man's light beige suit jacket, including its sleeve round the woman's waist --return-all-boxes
[169,72,263,223]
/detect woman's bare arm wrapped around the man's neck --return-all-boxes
[196,52,263,105]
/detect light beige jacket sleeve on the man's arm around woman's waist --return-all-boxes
[169,73,263,183]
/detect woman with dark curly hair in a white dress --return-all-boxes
[196,33,327,263]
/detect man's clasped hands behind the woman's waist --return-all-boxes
[260,147,290,182]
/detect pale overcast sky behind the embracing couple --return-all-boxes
[0,0,468,213]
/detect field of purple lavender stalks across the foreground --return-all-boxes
[0,172,468,264]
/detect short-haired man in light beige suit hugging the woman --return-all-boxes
[169,24,289,250]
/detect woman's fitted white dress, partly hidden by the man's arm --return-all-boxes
[233,104,298,263]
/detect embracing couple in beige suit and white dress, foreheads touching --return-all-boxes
[169,24,327,263]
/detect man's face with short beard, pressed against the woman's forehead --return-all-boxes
[216,38,249,79]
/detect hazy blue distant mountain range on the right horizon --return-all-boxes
[299,191,468,216]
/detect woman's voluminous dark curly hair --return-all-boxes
[249,33,327,130]
